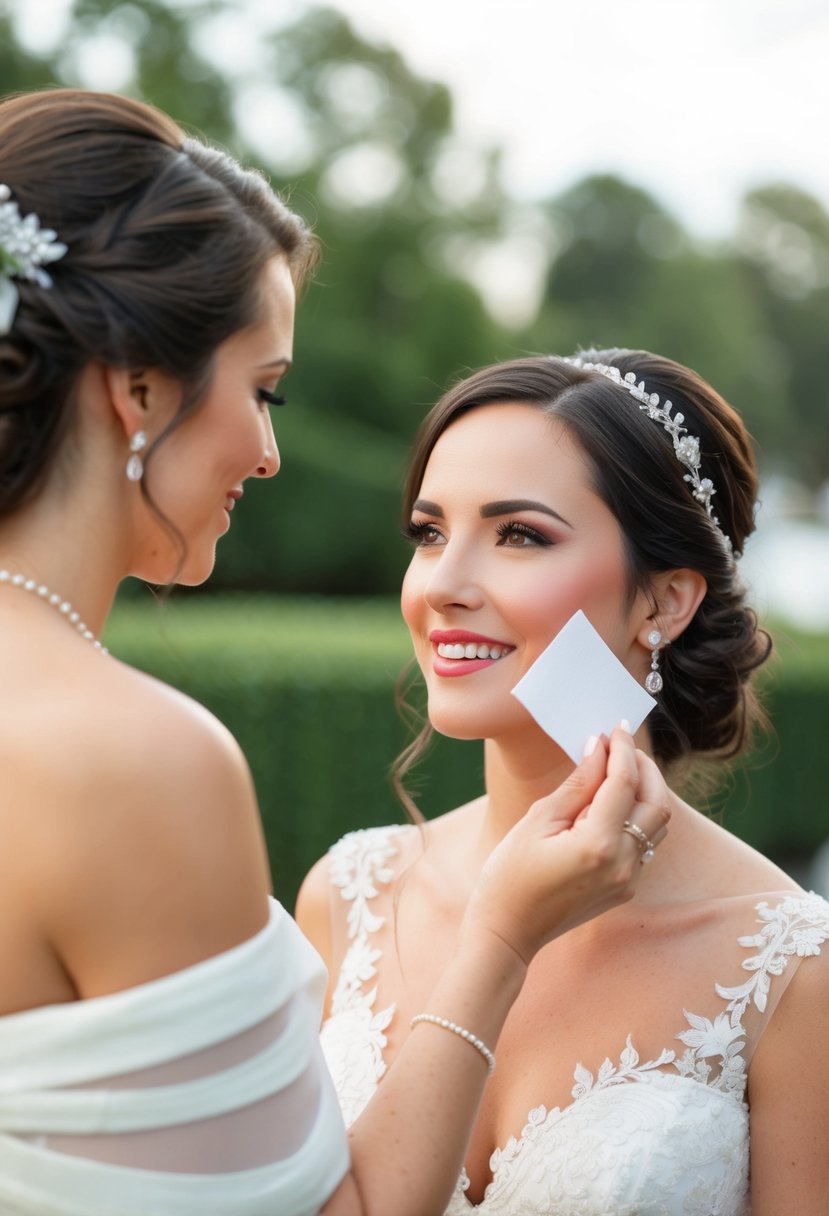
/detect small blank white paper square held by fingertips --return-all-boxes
[512,609,656,764]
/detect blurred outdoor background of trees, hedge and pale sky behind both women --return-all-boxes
[0,0,829,905]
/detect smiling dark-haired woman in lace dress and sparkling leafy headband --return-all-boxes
[298,350,829,1216]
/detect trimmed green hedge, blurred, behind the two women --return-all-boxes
[106,596,829,906]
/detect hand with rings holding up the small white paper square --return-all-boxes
[462,727,671,963]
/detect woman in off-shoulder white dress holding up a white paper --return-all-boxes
[0,90,666,1216]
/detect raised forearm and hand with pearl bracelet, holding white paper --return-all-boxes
[308,731,667,1216]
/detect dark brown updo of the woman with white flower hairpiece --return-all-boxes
[0,89,315,517]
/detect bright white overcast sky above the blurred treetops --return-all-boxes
[12,0,829,237]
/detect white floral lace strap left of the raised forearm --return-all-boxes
[329,828,401,1080]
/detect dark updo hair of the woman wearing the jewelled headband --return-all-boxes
[404,350,772,769]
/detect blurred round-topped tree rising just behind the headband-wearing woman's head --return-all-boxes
[532,176,780,462]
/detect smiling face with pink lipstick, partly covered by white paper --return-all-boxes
[401,404,648,738]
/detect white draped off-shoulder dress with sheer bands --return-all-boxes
[0,900,348,1216]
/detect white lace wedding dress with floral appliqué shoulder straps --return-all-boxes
[321,827,829,1216]
